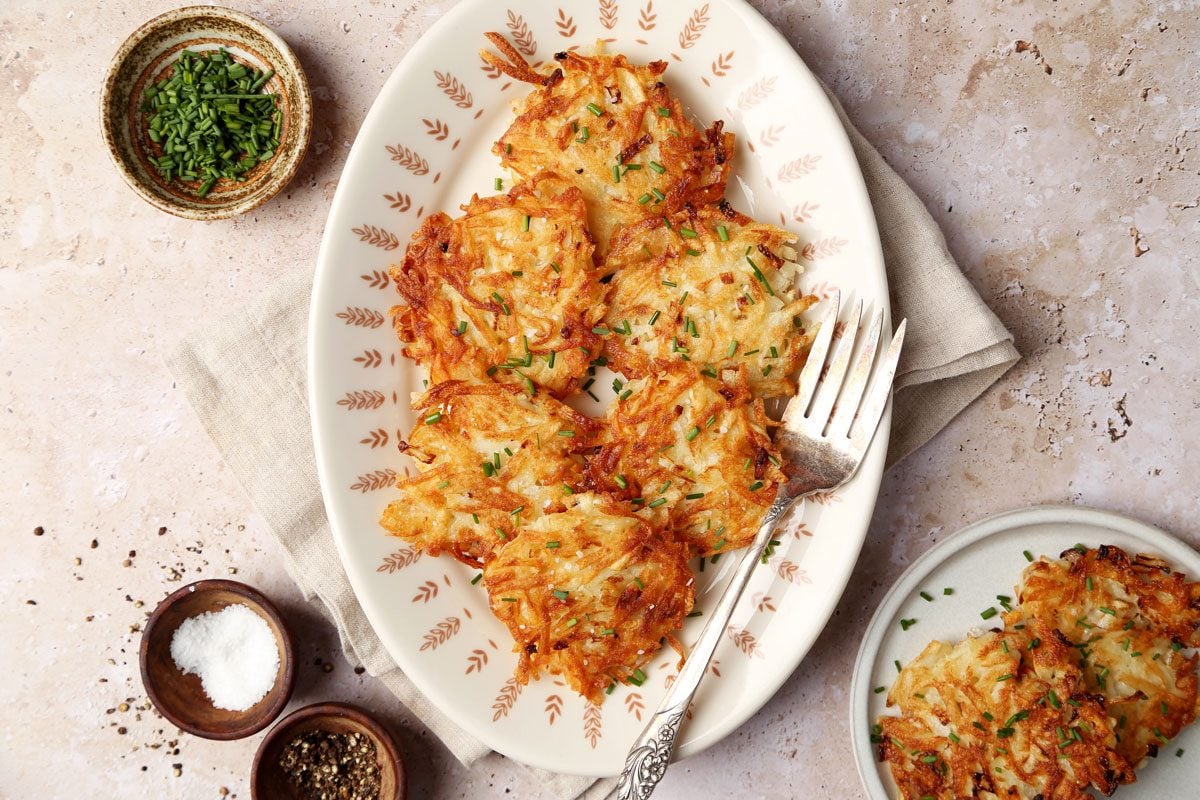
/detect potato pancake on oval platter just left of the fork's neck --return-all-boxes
[586,361,786,555]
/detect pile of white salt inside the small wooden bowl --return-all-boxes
[170,603,280,711]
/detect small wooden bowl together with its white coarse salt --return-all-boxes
[139,581,295,740]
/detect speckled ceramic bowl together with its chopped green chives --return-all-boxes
[101,6,312,219]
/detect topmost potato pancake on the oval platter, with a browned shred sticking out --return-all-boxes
[481,34,733,255]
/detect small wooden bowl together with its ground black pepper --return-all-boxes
[250,703,408,800]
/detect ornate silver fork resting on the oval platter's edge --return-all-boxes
[616,294,907,800]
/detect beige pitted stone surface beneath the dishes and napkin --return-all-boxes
[0,0,1200,799]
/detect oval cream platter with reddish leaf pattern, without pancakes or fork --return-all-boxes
[308,0,888,776]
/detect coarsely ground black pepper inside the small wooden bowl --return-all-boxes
[280,730,379,800]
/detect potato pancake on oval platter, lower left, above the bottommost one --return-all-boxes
[380,380,596,566]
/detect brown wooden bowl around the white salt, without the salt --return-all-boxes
[139,581,295,740]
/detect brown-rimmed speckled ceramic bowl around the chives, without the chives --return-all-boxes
[100,6,312,219]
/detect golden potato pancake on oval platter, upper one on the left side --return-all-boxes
[391,174,605,397]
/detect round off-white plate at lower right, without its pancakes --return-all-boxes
[850,506,1200,800]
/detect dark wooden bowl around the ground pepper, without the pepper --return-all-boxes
[250,703,408,800]
